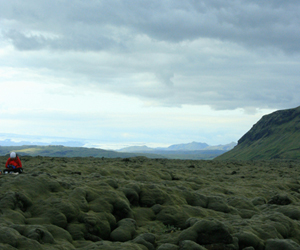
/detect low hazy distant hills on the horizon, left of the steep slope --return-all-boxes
[0,140,235,160]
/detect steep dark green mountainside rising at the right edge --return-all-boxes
[216,107,300,160]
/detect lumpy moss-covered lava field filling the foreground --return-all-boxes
[0,157,300,250]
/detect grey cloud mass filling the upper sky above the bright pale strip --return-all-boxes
[0,0,300,110]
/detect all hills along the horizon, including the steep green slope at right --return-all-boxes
[0,106,300,160]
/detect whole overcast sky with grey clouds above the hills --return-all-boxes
[0,0,300,148]
